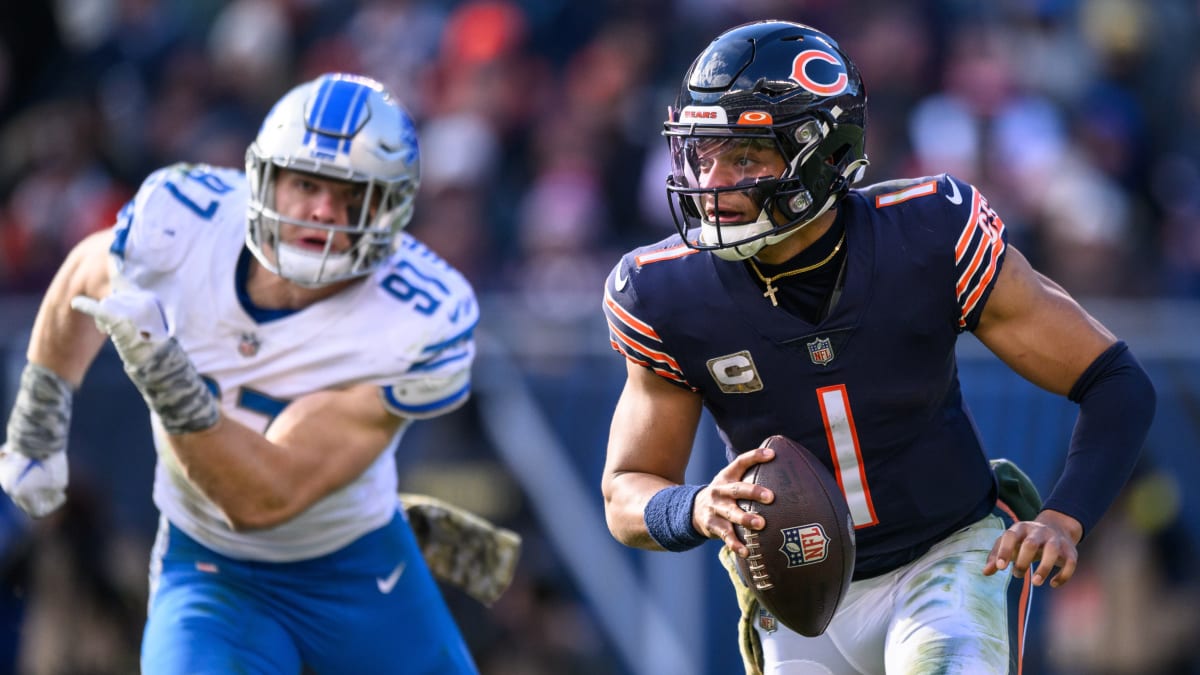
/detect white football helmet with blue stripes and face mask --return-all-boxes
[246,73,420,287]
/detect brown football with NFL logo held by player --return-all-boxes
[736,436,854,638]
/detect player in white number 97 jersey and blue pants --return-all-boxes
[0,74,478,674]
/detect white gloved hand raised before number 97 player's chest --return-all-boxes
[71,288,170,368]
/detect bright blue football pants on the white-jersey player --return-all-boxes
[142,512,476,675]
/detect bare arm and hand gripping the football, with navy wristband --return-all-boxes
[601,362,772,556]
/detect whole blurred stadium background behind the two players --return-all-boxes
[0,0,1200,675]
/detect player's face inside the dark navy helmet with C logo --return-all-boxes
[696,138,787,223]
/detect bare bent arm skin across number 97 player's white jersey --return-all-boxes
[170,384,403,530]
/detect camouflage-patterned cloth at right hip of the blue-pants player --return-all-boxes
[400,492,521,607]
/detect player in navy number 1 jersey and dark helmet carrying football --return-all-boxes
[602,22,1154,675]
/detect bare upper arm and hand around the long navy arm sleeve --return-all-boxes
[976,246,1116,587]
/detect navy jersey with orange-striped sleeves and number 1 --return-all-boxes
[605,174,1007,578]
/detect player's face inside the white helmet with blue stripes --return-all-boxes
[275,169,367,253]
